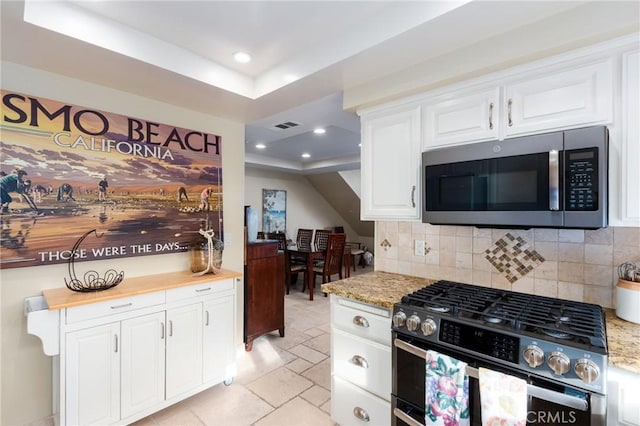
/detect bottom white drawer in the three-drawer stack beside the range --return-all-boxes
[331,376,391,426]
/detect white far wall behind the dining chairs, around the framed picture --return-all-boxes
[245,168,358,241]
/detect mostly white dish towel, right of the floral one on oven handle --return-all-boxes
[478,367,527,426]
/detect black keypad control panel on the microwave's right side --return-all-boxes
[564,148,598,211]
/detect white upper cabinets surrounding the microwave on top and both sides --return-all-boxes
[361,34,640,226]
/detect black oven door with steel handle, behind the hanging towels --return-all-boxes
[391,332,606,426]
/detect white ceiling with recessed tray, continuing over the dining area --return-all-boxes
[1,0,636,174]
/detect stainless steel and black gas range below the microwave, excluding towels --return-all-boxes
[392,281,607,426]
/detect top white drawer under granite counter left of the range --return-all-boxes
[331,299,391,346]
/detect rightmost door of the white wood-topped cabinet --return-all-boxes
[203,295,235,382]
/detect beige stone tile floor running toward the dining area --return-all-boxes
[135,266,373,426]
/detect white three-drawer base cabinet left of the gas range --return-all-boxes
[331,295,391,426]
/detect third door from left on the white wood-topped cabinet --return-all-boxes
[166,303,202,399]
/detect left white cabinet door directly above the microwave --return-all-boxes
[423,87,501,150]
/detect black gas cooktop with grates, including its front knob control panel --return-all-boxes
[392,281,607,394]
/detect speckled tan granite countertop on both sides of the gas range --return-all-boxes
[322,271,640,374]
